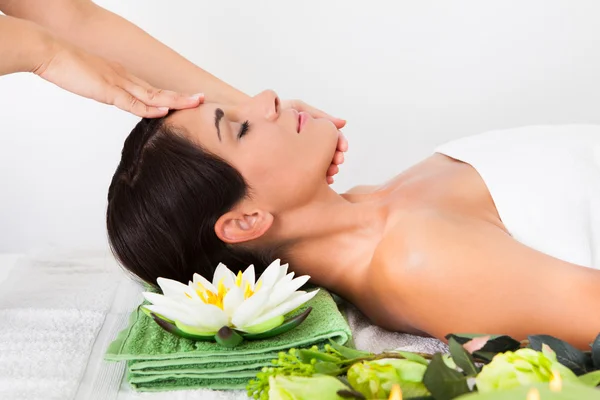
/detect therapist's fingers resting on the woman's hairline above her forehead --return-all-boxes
[121,74,204,110]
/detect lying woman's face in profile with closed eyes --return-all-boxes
[168,91,338,212]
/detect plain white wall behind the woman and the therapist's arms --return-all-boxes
[0,0,600,251]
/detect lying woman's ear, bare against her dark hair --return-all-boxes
[215,210,273,244]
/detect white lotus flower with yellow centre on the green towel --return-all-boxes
[143,259,318,336]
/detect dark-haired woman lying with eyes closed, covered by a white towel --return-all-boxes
[107,91,600,348]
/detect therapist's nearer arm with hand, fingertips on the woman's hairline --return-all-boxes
[0,16,201,117]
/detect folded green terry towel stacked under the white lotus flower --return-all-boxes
[105,289,351,392]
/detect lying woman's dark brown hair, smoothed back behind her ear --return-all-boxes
[106,117,274,285]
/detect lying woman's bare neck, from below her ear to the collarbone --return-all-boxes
[272,188,387,300]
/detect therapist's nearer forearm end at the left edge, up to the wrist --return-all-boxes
[0,15,52,75]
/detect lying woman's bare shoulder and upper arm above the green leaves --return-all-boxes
[384,222,600,349]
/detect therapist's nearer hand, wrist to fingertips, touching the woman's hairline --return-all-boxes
[33,40,204,118]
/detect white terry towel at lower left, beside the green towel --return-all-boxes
[0,248,123,400]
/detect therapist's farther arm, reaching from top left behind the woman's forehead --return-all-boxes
[0,0,248,104]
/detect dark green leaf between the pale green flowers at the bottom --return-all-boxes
[423,353,469,400]
